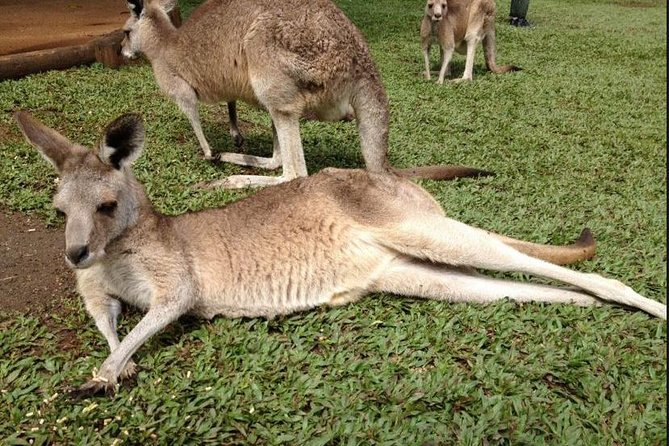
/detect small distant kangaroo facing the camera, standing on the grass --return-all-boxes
[420,0,520,84]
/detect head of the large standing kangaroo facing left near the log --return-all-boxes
[121,0,177,59]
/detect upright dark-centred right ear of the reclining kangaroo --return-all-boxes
[99,113,145,170]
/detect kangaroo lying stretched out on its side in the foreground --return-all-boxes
[15,112,666,394]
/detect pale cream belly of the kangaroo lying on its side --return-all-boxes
[193,230,393,318]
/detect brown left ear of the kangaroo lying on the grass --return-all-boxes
[14,111,77,173]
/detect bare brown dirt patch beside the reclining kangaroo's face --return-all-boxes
[0,209,77,316]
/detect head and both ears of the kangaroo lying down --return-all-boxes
[15,112,146,268]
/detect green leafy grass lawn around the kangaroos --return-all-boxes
[0,0,667,445]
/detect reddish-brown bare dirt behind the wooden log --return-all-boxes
[0,0,130,56]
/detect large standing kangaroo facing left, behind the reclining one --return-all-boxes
[122,0,489,188]
